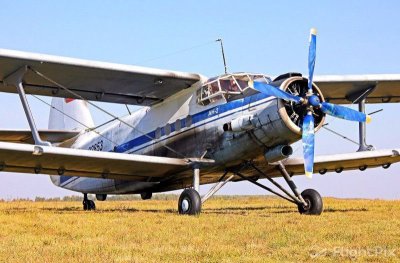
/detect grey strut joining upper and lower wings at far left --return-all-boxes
[4,66,51,146]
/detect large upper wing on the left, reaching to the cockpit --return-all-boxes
[0,49,200,105]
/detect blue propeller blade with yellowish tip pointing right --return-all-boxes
[320,102,371,123]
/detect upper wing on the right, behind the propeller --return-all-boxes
[314,74,400,104]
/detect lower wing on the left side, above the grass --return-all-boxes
[0,142,213,180]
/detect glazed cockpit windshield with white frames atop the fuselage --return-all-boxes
[197,73,271,105]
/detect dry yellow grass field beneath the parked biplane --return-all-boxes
[0,197,400,262]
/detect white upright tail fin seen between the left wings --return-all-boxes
[49,98,94,130]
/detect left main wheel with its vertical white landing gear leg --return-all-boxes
[178,167,201,215]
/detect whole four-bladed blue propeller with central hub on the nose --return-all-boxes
[254,28,371,178]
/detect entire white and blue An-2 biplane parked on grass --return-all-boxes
[0,30,400,215]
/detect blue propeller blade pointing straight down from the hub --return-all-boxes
[302,111,314,178]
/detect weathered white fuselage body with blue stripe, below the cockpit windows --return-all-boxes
[51,77,299,194]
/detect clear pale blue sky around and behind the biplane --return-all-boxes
[0,0,400,199]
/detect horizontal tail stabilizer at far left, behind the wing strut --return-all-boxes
[0,130,80,144]
